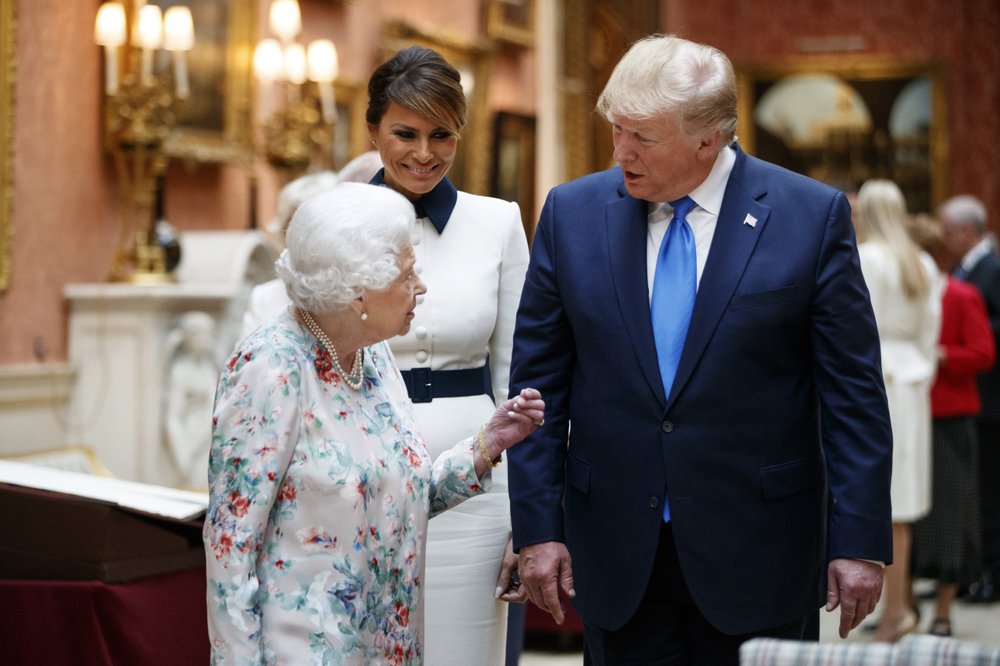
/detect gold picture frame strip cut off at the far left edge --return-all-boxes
[0,2,17,294]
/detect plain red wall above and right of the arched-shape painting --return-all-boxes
[662,0,1000,223]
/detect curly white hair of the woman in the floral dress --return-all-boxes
[274,183,415,313]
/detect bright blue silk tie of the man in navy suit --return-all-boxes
[650,197,698,522]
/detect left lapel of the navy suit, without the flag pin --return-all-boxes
[606,191,666,404]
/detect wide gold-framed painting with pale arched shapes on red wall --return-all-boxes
[737,57,948,213]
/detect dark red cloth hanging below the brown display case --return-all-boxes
[0,569,209,666]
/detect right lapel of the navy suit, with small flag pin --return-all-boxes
[668,152,771,407]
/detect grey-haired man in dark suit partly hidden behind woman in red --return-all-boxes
[937,194,1000,602]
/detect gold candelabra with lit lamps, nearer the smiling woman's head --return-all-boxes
[253,0,338,174]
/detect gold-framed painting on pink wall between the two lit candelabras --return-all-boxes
[151,0,257,162]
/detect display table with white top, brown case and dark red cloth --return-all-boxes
[0,461,209,666]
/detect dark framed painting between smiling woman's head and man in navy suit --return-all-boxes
[490,111,535,244]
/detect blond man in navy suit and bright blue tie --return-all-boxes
[508,35,892,666]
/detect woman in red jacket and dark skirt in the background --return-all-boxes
[910,214,996,636]
